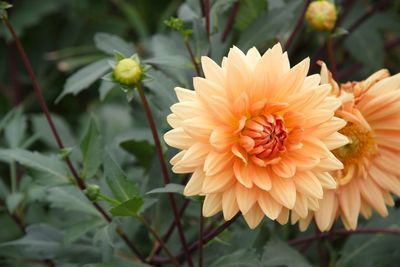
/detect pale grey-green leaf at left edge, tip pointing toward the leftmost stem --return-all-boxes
[0,149,69,183]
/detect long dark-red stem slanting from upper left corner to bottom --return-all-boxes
[3,18,146,262]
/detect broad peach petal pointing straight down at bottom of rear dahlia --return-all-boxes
[338,182,361,229]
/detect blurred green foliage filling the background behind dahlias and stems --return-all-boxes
[0,0,400,267]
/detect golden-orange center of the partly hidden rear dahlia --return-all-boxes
[332,123,376,185]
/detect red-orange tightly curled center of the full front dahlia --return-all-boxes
[239,114,288,166]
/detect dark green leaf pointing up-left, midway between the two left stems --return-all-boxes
[103,151,140,202]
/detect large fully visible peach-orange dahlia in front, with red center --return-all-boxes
[164,44,347,228]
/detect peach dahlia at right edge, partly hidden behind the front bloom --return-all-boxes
[293,64,400,231]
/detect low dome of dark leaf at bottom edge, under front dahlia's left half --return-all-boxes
[210,249,261,267]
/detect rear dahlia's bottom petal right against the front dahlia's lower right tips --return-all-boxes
[314,190,338,231]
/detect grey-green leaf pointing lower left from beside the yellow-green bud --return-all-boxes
[56,58,111,103]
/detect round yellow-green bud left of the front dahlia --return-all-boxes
[114,58,143,86]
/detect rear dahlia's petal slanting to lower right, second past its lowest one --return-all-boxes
[358,179,388,217]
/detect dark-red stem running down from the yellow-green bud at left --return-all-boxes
[137,84,193,266]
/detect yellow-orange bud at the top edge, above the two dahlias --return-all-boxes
[306,0,337,31]
